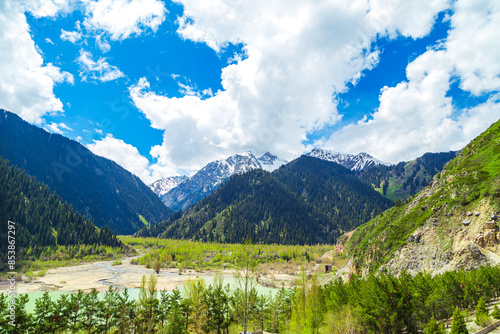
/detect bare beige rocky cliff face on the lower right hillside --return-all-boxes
[380,196,500,274]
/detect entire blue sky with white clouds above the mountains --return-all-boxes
[0,0,500,183]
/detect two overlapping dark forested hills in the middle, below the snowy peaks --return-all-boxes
[136,155,393,244]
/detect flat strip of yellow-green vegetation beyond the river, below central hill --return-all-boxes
[119,236,346,275]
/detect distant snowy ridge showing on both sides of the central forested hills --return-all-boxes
[149,148,457,211]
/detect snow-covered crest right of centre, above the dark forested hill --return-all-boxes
[305,148,390,171]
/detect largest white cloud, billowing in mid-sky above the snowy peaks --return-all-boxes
[130,0,449,172]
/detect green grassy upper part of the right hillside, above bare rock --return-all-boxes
[347,121,500,271]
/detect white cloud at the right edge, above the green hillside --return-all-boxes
[324,0,500,162]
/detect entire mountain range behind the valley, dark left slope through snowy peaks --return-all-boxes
[0,110,456,244]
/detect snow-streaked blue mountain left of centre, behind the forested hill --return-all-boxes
[149,152,286,211]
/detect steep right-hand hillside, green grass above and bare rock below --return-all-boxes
[347,121,500,273]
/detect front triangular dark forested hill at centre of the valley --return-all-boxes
[138,169,336,244]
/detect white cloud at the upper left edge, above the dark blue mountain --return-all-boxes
[0,0,73,123]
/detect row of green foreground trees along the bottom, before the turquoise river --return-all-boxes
[0,257,500,334]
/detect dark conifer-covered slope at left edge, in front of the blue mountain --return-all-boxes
[0,158,122,260]
